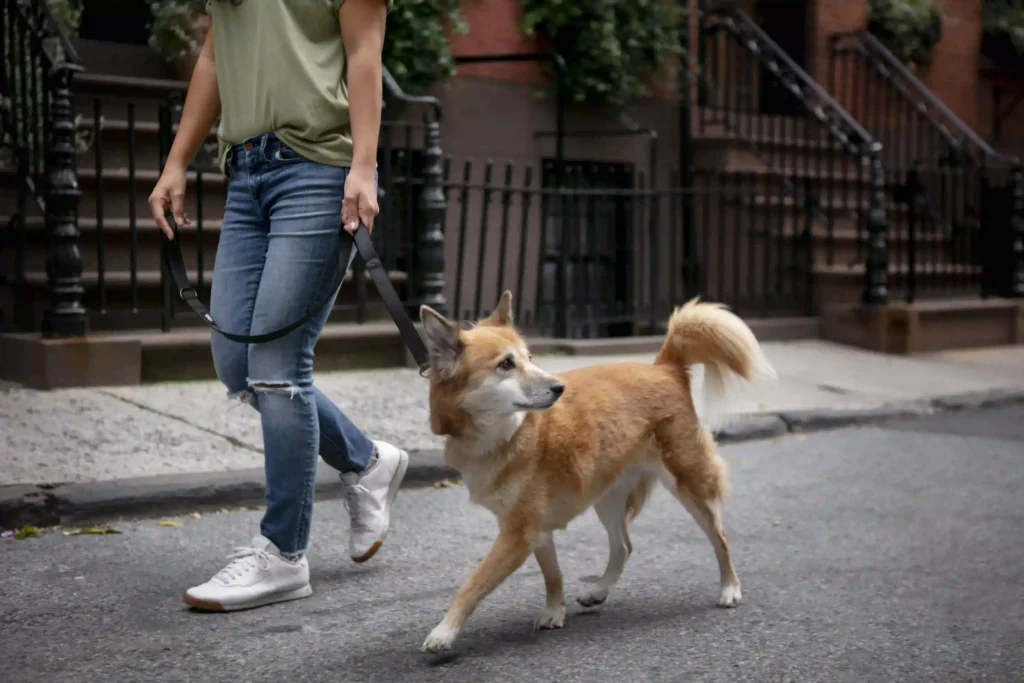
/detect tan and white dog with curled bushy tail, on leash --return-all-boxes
[420,292,775,652]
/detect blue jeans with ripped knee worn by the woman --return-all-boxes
[210,134,374,557]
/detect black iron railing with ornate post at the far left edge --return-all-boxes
[0,0,88,337]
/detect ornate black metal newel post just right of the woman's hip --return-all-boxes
[413,116,446,317]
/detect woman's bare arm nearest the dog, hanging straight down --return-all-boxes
[338,0,387,231]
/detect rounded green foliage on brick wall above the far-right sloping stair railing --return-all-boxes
[867,0,944,65]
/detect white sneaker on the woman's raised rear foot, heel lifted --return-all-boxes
[341,441,409,562]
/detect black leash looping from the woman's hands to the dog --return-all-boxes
[164,214,430,375]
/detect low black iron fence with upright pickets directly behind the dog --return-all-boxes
[444,159,812,338]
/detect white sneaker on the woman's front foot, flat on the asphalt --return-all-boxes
[185,536,313,612]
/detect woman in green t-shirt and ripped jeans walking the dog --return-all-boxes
[150,0,409,611]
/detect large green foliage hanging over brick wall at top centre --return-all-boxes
[520,0,686,104]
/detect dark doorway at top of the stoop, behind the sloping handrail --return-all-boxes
[754,0,810,116]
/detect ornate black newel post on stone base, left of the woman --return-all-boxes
[43,62,89,337]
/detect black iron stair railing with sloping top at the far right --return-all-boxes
[828,32,1024,301]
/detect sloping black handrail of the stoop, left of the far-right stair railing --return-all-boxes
[705,5,882,156]
